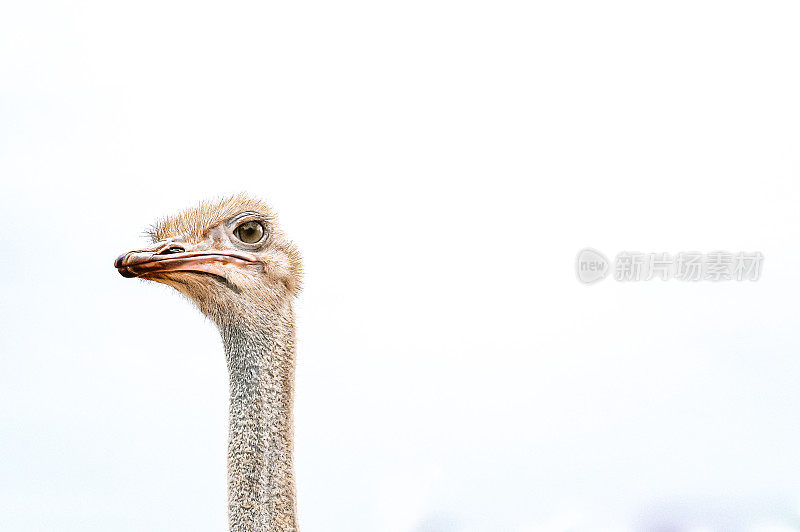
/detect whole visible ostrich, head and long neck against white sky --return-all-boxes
[114,194,301,532]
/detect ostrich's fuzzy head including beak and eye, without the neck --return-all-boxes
[114,194,301,327]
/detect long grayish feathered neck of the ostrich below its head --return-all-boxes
[220,307,298,532]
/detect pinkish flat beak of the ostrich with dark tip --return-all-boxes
[114,241,257,279]
